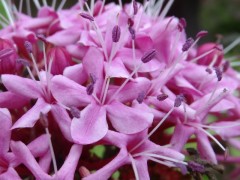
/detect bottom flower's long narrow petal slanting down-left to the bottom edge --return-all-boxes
[83,149,130,180]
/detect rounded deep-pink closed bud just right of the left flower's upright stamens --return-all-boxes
[47,47,72,75]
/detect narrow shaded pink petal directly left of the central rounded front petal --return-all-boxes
[51,105,72,142]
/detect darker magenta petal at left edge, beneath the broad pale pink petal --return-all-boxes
[0,91,29,109]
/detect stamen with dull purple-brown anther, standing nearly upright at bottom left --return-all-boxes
[40,113,57,175]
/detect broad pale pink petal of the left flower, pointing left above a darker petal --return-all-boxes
[2,75,42,98]
